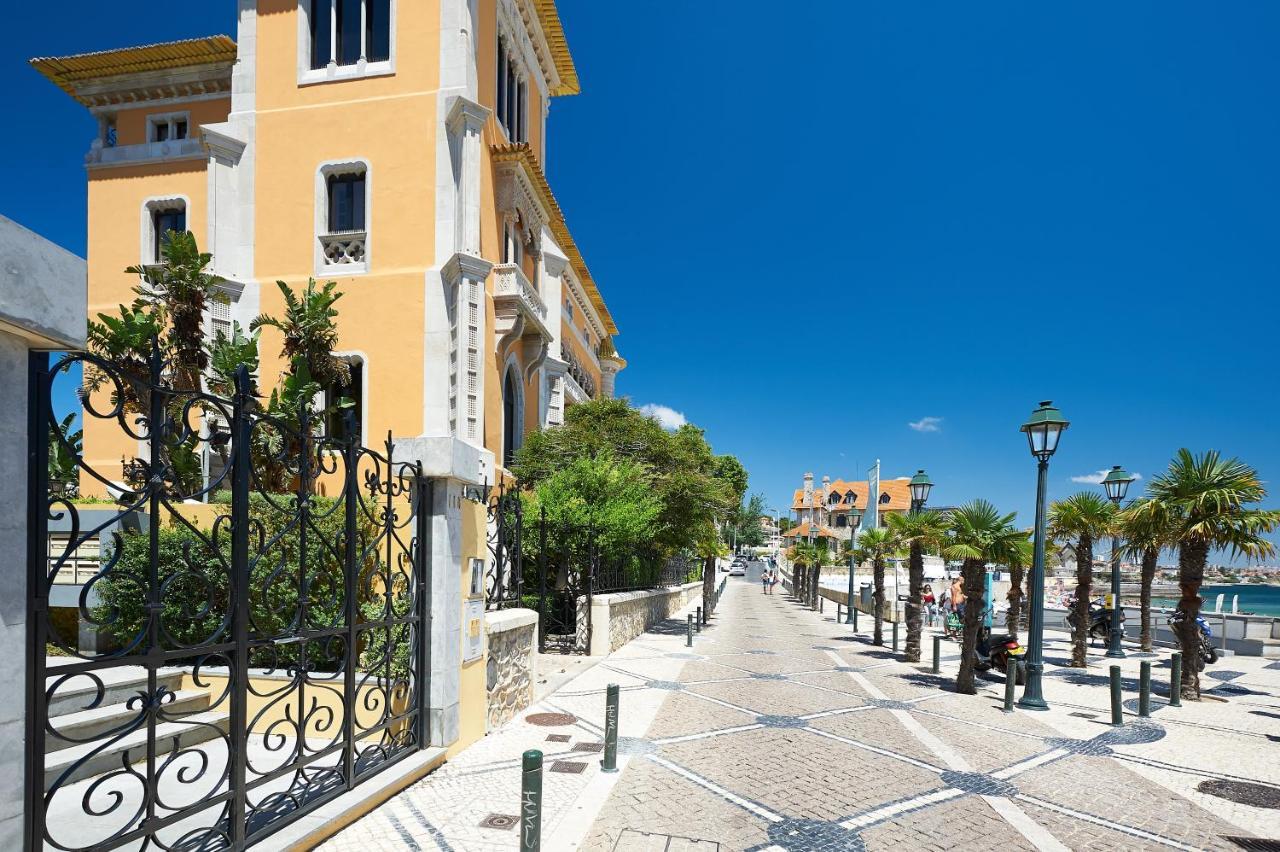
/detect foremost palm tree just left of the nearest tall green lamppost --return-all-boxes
[942,499,1027,695]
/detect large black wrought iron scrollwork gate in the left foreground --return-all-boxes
[27,348,430,851]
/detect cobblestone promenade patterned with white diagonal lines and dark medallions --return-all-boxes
[583,581,1280,852]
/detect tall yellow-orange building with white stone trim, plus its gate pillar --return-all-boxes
[33,0,626,748]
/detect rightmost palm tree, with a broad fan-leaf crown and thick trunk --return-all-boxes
[1139,448,1280,701]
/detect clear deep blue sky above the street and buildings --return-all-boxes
[10,0,1280,560]
